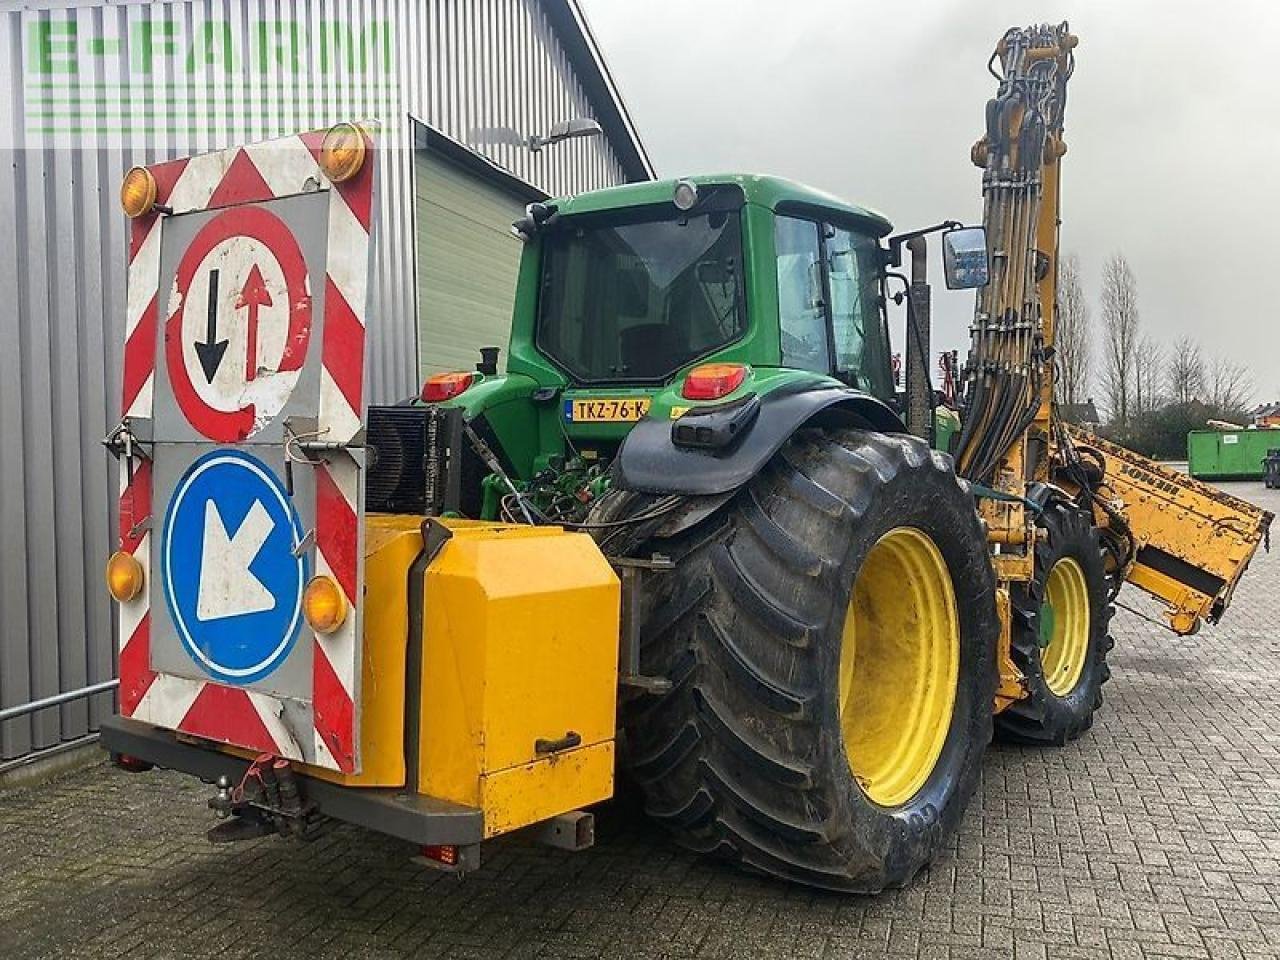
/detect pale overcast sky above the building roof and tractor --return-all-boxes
[581,0,1280,399]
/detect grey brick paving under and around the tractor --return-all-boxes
[0,484,1280,960]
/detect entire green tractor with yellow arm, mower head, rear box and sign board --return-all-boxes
[102,23,1271,892]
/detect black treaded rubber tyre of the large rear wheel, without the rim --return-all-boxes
[623,430,996,892]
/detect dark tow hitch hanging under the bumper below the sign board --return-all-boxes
[209,756,317,844]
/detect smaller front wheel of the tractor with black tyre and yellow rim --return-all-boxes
[996,503,1115,746]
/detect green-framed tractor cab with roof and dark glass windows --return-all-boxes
[511,175,893,401]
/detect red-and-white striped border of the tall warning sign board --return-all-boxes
[111,123,378,773]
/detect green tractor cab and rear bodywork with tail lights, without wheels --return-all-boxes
[394,174,926,521]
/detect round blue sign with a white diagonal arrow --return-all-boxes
[160,449,308,685]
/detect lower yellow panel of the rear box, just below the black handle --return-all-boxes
[480,740,613,837]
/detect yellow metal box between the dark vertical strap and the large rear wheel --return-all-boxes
[419,521,620,826]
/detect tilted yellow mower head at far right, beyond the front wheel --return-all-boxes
[1069,428,1274,635]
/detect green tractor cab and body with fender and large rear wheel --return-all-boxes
[369,175,1000,891]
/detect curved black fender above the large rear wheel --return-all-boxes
[613,381,906,497]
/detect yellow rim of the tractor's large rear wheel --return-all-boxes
[840,527,960,806]
